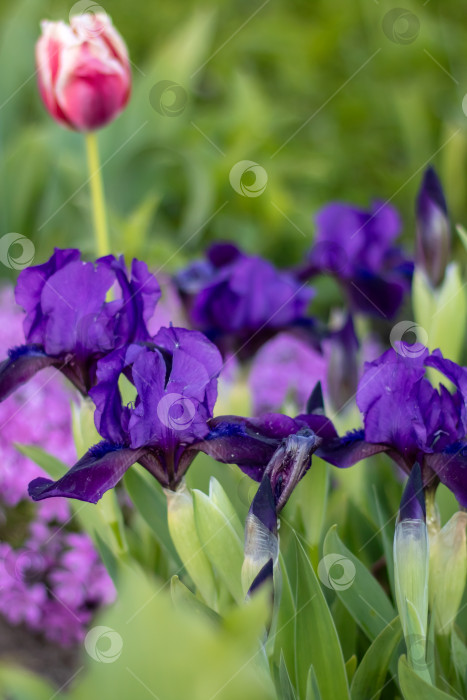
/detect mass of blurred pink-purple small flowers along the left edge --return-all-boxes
[0,288,115,645]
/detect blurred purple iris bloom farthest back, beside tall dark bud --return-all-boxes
[298,202,413,318]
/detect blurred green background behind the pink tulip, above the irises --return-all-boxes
[0,0,467,278]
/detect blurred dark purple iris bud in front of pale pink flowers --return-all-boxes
[327,314,359,412]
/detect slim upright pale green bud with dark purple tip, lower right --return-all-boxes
[394,464,429,679]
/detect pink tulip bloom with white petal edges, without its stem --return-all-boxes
[36,13,131,131]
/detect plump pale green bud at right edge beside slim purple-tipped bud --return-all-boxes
[430,512,467,634]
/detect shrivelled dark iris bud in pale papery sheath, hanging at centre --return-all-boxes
[242,428,322,594]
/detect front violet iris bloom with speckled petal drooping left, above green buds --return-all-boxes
[29,328,222,503]
